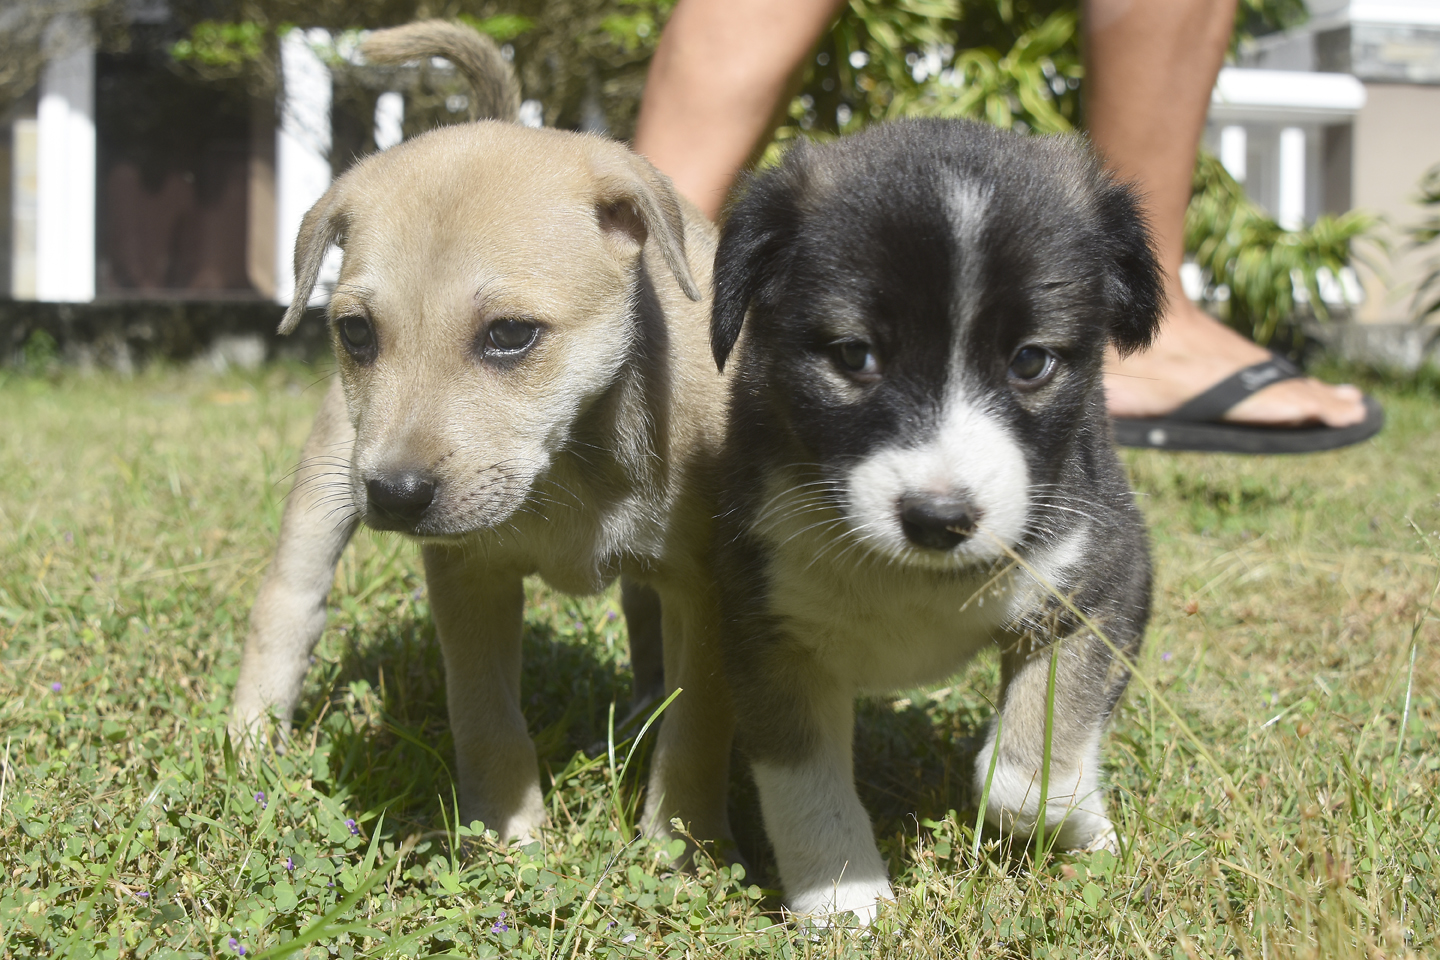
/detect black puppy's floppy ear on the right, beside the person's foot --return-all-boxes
[1097,181,1165,357]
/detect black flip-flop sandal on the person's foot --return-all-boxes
[1112,357,1385,453]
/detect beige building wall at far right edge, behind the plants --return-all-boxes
[1351,83,1440,322]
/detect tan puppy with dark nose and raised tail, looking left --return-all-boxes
[233,23,733,838]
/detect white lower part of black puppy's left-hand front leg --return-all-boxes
[753,756,894,924]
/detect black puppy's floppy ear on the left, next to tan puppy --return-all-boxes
[710,161,805,371]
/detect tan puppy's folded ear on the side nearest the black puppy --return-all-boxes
[595,154,701,301]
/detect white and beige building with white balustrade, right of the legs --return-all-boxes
[1207,0,1440,322]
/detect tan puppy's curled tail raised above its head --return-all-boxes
[360,20,520,122]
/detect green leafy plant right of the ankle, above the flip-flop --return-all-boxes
[1185,153,1375,351]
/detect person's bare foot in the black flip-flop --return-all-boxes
[1104,296,1365,427]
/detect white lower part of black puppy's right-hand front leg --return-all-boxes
[975,724,1115,849]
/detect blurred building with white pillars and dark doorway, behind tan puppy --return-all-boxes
[0,24,405,302]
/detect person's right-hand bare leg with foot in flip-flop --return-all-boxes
[1084,0,1365,426]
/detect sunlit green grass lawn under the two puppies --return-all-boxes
[0,367,1440,959]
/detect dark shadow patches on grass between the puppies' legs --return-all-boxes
[300,600,1008,887]
